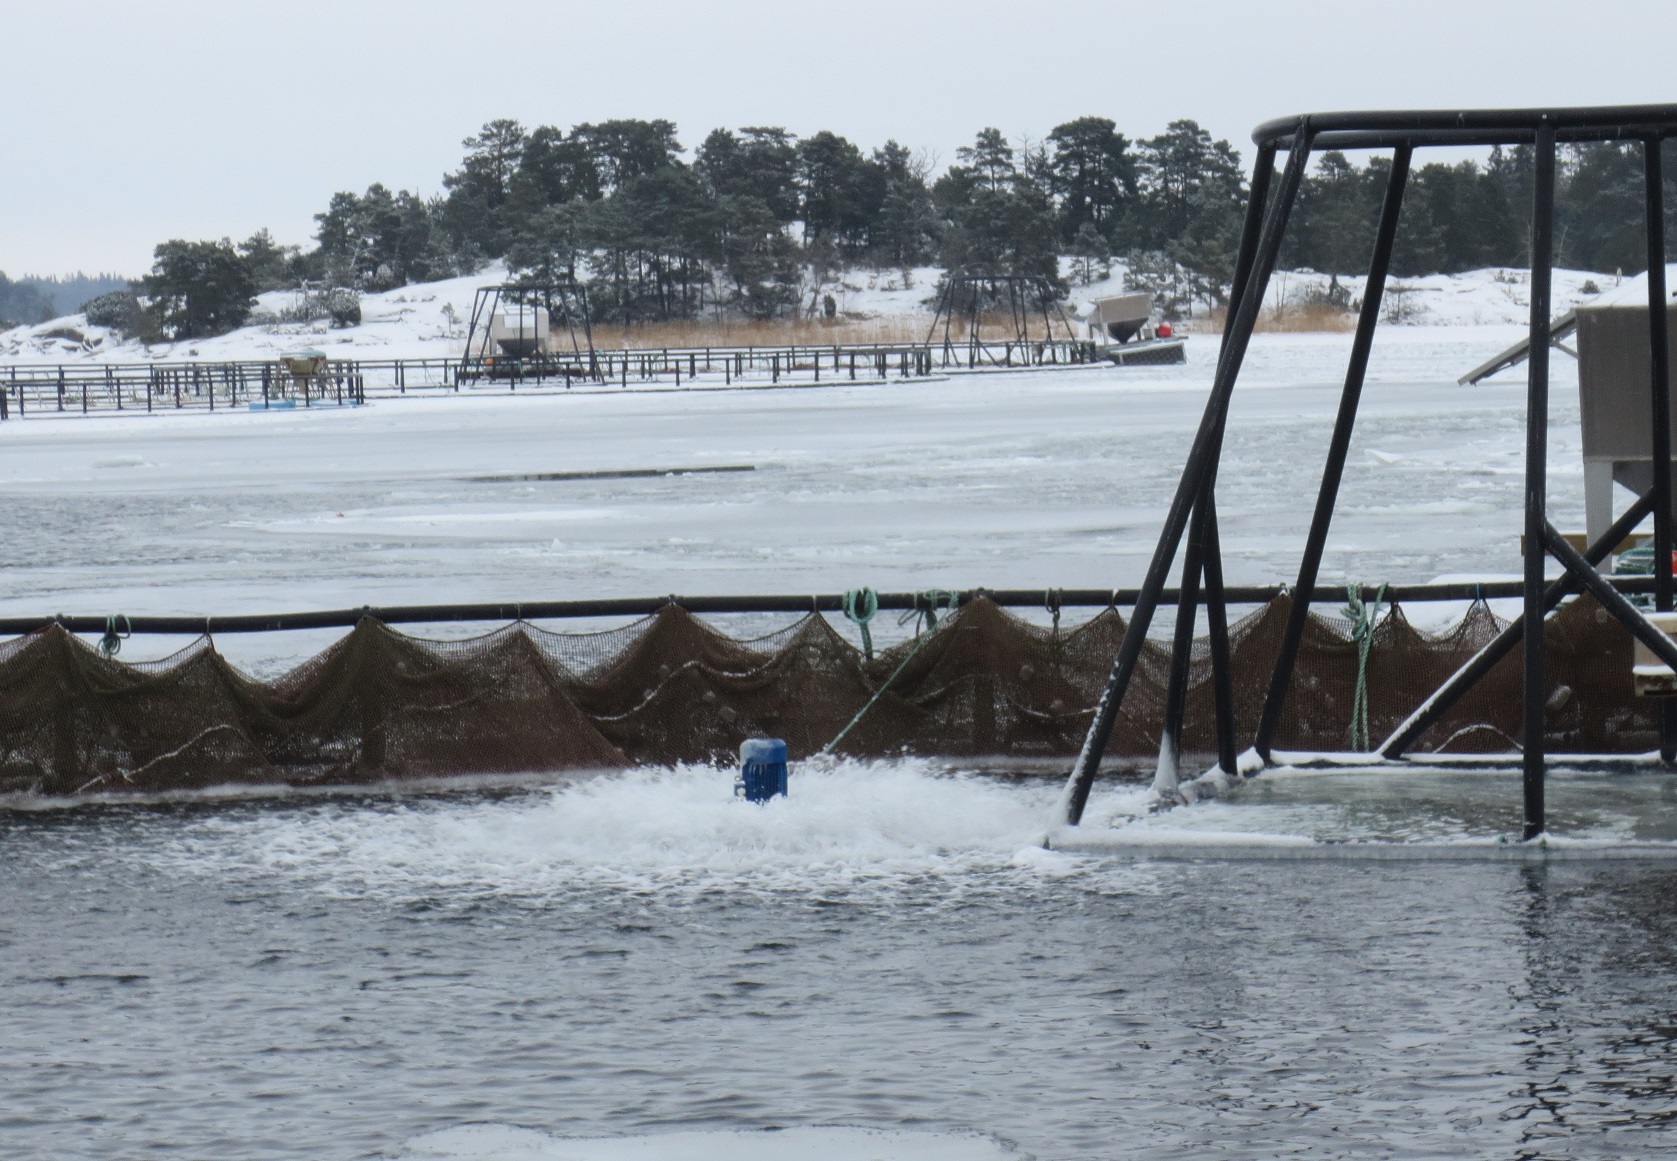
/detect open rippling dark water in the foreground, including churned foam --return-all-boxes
[0,770,1677,1161]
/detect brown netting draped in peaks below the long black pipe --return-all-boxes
[0,597,1657,794]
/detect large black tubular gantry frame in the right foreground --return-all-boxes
[1063,106,1677,839]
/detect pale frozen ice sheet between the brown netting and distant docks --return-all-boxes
[0,327,1583,669]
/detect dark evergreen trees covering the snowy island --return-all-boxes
[22,117,1677,337]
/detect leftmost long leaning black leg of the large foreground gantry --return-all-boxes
[1062,119,1313,825]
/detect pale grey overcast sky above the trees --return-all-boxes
[0,0,1677,277]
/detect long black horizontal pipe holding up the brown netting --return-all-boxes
[0,575,1655,636]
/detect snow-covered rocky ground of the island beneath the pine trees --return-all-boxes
[0,262,1650,364]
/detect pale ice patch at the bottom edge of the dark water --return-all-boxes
[401,1124,1020,1161]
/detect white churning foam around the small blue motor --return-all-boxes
[140,760,1142,896]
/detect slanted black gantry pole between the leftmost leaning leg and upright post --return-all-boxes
[1253,144,1412,762]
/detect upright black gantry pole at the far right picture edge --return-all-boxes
[1642,136,1677,762]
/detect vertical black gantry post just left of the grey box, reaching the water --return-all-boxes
[1519,119,1556,839]
